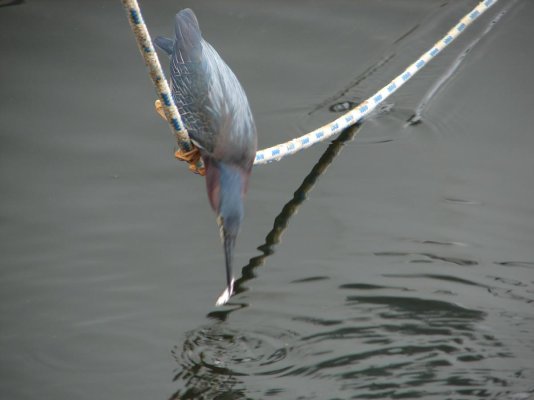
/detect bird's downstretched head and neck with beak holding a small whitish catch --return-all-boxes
[206,160,250,304]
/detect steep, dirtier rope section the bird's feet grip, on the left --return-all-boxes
[122,0,202,170]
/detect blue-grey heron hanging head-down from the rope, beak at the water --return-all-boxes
[154,9,258,305]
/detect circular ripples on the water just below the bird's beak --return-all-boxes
[171,323,302,400]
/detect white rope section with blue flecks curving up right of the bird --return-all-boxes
[254,0,498,165]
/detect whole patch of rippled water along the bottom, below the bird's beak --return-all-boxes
[172,286,532,400]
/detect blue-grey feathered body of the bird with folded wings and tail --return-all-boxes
[164,9,256,163]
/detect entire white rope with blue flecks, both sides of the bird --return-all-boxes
[122,0,498,168]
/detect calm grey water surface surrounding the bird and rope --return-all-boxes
[0,0,534,400]
